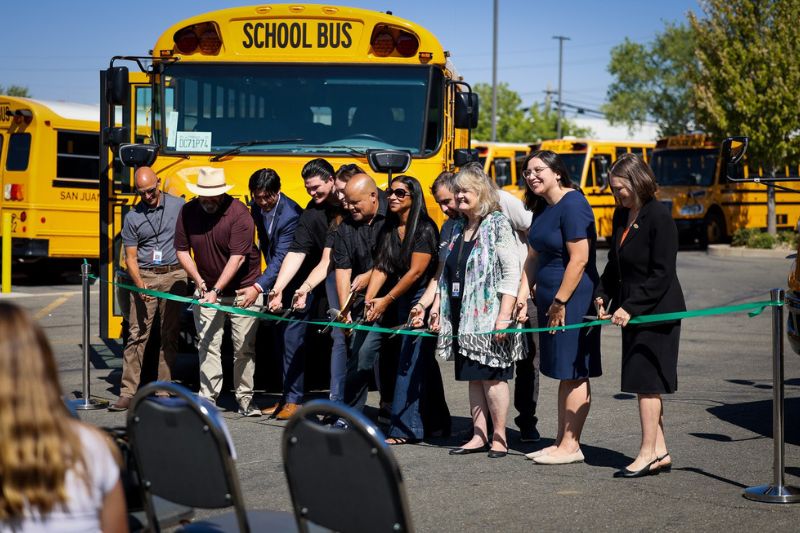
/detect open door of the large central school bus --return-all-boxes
[100,66,152,339]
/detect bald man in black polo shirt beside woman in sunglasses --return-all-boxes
[333,174,388,409]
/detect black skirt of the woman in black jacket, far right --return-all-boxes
[621,322,681,394]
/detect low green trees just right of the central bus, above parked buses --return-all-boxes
[472,83,591,143]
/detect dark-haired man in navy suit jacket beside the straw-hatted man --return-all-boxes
[237,168,305,418]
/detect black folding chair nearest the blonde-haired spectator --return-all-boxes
[128,381,297,532]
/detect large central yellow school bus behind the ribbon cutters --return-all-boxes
[100,4,478,337]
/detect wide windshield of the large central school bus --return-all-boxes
[156,63,444,156]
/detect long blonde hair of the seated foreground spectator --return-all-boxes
[0,302,88,520]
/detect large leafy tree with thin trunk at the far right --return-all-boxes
[689,0,800,235]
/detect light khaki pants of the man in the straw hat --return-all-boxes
[194,293,264,407]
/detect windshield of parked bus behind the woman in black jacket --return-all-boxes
[650,149,717,187]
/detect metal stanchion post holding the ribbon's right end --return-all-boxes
[743,289,800,503]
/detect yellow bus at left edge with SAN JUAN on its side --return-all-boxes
[0,96,100,261]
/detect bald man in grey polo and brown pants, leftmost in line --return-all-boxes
[108,167,187,411]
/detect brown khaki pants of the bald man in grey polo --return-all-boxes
[120,268,187,398]
